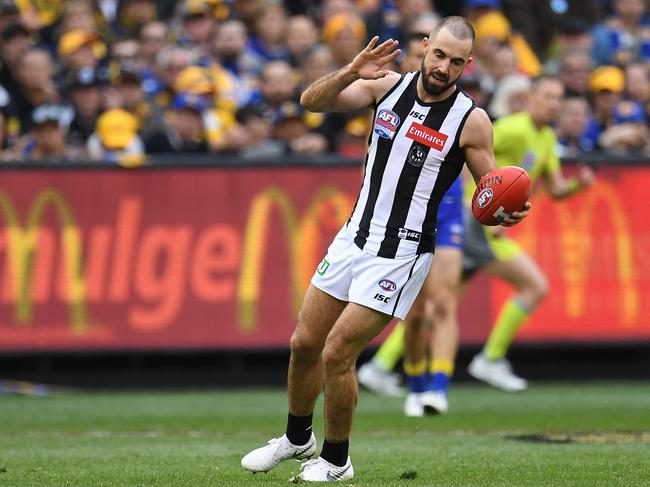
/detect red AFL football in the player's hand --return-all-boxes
[472,166,530,226]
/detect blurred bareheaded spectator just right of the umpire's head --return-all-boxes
[555,96,595,157]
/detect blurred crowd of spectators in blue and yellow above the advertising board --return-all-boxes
[0,0,650,165]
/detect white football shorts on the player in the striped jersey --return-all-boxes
[311,226,433,320]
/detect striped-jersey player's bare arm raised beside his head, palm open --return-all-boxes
[300,36,400,112]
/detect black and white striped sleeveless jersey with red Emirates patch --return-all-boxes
[348,72,475,258]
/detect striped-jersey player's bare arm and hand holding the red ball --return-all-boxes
[460,108,530,227]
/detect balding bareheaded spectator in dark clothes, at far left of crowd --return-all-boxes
[12,48,60,134]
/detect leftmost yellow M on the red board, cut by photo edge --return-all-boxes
[0,188,88,332]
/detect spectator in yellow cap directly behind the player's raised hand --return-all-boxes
[323,13,367,67]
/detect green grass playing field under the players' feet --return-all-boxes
[0,383,650,487]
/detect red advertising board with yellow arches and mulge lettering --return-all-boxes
[0,167,650,352]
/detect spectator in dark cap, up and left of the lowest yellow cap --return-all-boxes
[68,68,105,147]
